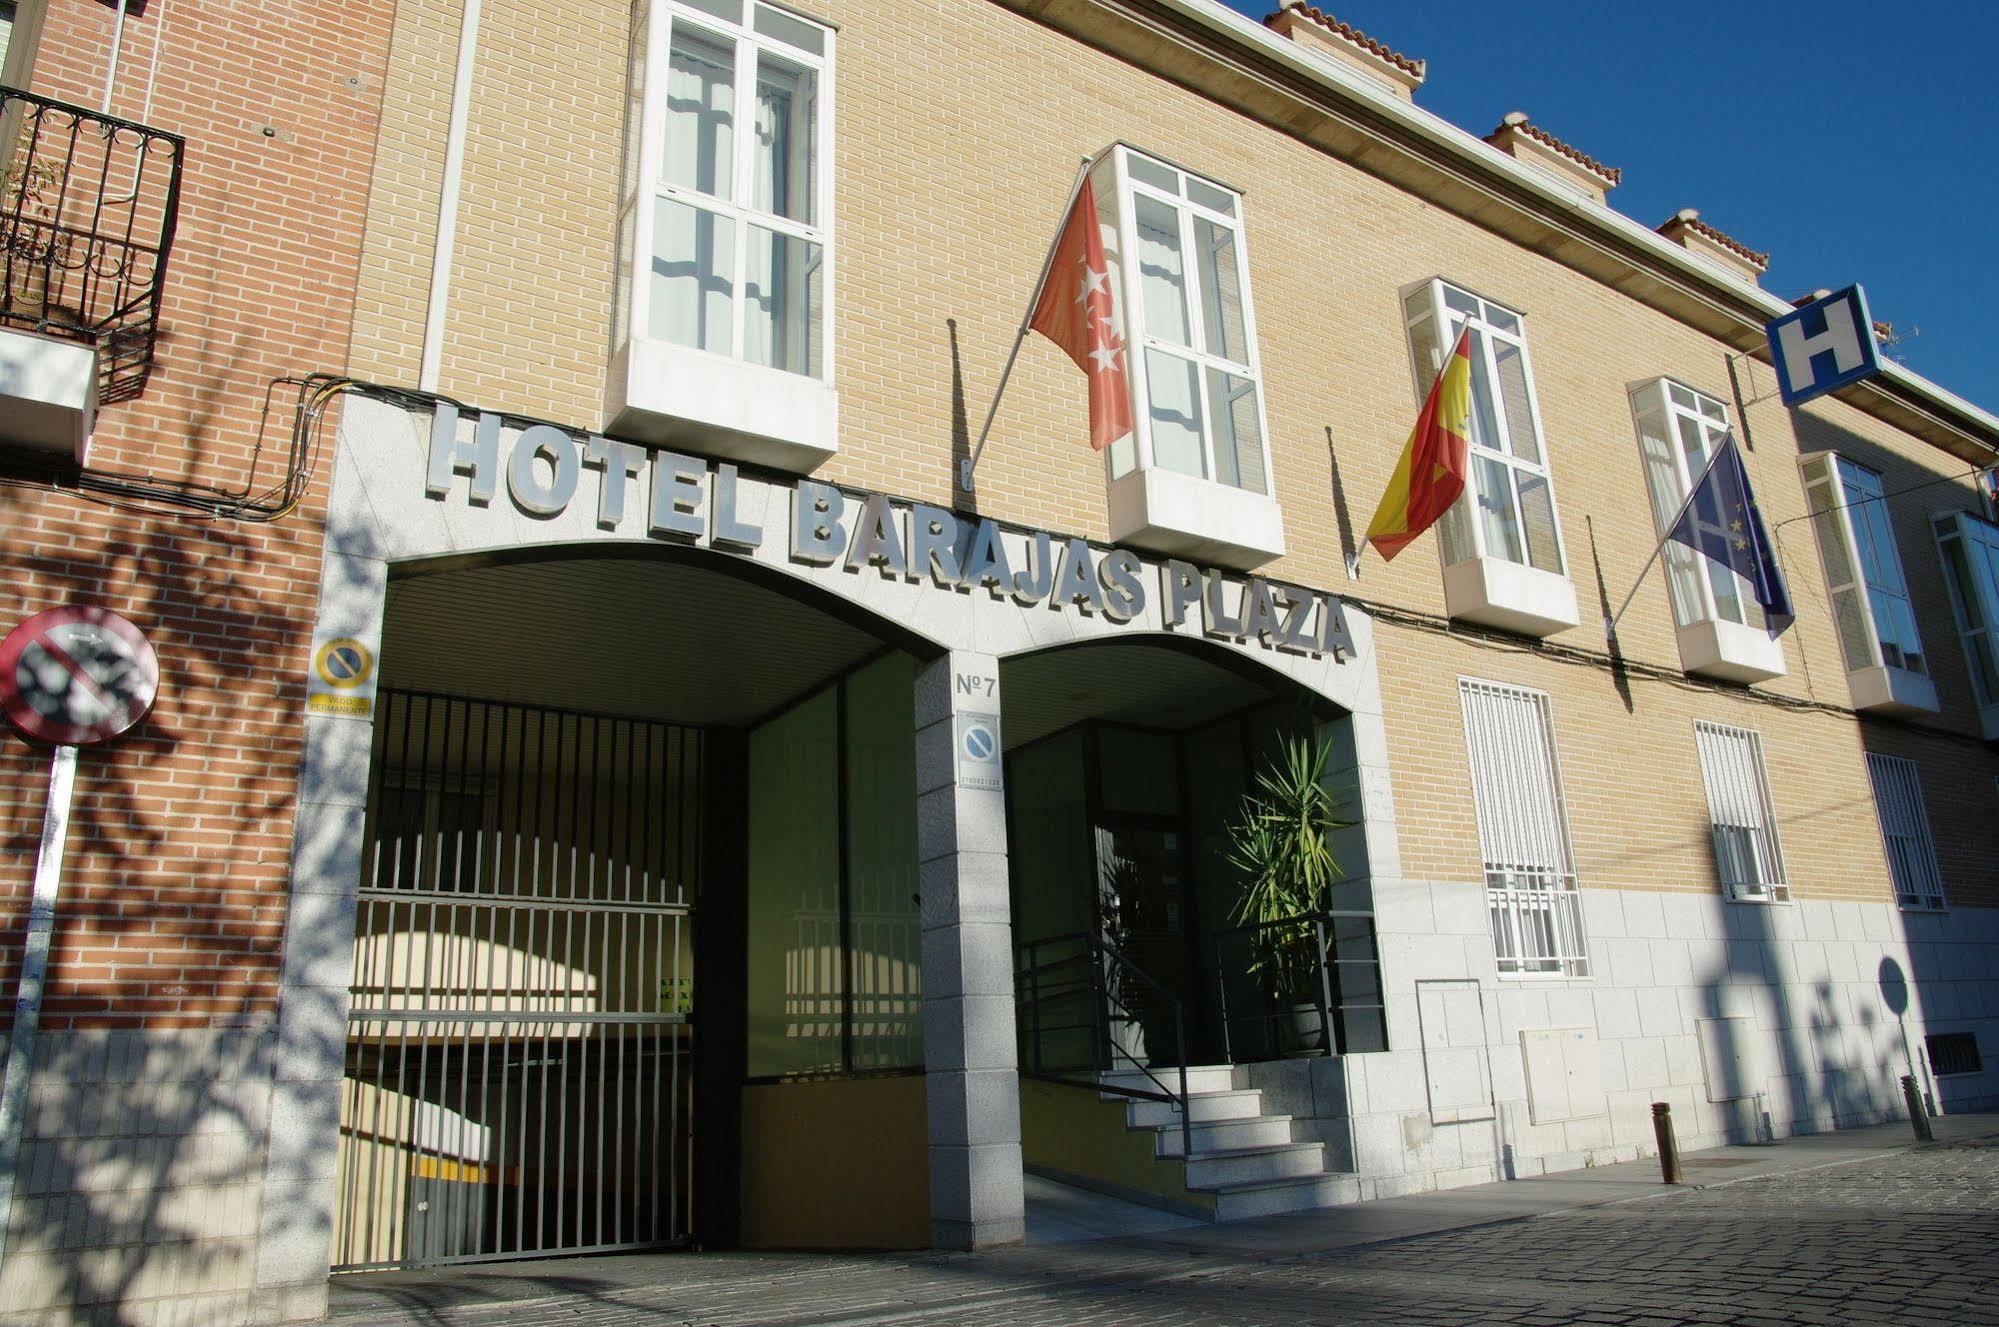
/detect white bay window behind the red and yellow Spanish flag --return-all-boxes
[1403,280,1579,636]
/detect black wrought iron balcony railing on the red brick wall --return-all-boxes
[0,88,186,404]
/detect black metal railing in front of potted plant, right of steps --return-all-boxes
[1215,909,1387,1063]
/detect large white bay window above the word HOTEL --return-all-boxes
[610,0,838,470]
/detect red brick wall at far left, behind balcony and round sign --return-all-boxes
[0,0,394,1029]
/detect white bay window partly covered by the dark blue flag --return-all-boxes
[1631,378,1785,681]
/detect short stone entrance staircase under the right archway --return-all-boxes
[1095,1065,1359,1221]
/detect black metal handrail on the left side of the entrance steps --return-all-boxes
[1013,931,1193,1157]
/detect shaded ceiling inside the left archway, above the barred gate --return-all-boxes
[382,558,882,725]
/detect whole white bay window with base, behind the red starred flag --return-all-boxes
[1091,144,1283,568]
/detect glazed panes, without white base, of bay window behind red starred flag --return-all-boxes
[1091,144,1269,494]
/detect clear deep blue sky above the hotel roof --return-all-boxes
[1229,0,1999,412]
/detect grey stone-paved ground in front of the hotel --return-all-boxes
[334,1117,1999,1327]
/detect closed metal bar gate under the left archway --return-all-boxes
[332,689,702,1271]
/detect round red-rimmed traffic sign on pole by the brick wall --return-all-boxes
[0,608,160,745]
